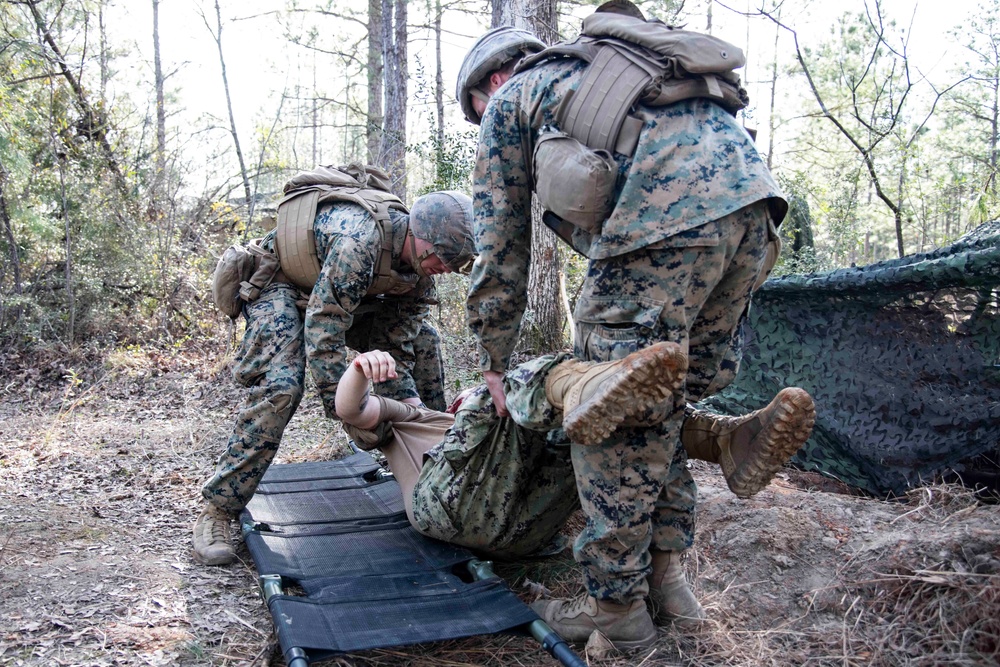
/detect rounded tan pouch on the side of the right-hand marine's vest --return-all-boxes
[533,130,618,234]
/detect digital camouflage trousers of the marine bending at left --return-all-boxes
[202,283,445,512]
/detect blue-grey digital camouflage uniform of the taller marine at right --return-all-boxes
[468,60,781,602]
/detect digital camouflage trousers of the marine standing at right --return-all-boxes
[571,202,768,602]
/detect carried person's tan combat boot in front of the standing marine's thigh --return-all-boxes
[545,343,687,445]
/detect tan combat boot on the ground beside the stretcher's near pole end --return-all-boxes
[531,593,656,651]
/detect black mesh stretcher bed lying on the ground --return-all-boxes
[241,453,538,659]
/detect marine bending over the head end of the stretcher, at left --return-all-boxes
[194,164,475,565]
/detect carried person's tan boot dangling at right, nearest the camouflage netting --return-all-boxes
[681,387,816,498]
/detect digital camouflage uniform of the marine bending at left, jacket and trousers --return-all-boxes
[202,202,445,512]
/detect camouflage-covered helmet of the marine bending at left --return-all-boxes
[410,190,476,275]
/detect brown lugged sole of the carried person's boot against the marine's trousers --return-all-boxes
[563,343,687,445]
